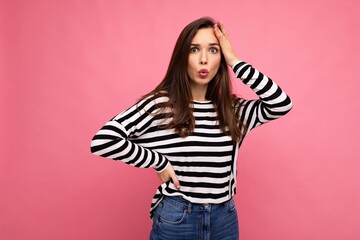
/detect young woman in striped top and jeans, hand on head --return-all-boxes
[91,18,292,240]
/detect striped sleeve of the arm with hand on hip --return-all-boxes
[91,94,168,172]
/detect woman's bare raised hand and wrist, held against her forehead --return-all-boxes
[214,23,240,67]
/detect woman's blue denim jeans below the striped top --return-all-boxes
[150,196,239,240]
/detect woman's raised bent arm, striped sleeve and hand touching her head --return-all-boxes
[214,23,292,131]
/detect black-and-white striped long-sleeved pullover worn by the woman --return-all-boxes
[91,61,292,217]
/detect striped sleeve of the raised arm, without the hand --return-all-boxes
[233,61,292,131]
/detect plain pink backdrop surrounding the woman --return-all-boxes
[0,0,360,240]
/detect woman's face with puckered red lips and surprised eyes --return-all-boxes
[187,28,221,88]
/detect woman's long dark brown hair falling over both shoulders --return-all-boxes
[143,17,245,141]
